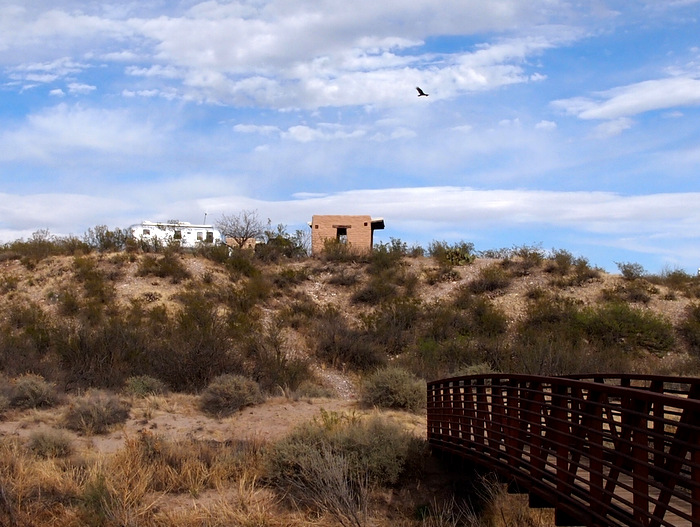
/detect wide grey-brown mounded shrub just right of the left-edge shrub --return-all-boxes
[62,391,130,434]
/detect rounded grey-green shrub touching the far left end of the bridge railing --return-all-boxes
[361,366,426,412]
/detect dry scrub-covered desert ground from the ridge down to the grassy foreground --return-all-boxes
[0,246,700,527]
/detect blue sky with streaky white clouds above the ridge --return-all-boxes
[0,0,700,274]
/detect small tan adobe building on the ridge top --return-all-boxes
[309,214,384,254]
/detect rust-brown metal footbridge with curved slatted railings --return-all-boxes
[428,375,700,527]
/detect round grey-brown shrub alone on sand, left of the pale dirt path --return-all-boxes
[199,374,264,417]
